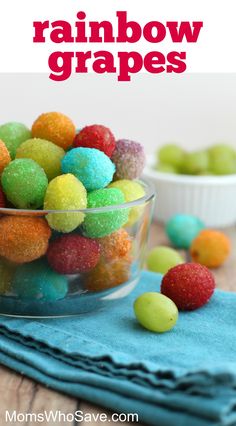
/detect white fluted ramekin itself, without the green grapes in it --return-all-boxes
[144,158,236,227]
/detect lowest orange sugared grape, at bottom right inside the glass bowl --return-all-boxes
[83,258,131,291]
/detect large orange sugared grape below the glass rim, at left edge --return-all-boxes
[0,216,51,263]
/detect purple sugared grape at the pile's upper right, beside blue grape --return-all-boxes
[111,139,145,180]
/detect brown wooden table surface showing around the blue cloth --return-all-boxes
[0,224,236,426]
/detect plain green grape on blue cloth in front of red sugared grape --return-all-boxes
[134,292,178,333]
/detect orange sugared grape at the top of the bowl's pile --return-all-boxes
[31,112,76,149]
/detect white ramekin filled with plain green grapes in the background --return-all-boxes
[144,143,236,227]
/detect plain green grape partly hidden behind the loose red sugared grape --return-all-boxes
[147,246,184,274]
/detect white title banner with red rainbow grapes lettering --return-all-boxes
[0,0,236,75]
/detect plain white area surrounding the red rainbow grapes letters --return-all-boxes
[0,0,236,72]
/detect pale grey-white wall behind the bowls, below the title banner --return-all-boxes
[0,73,236,152]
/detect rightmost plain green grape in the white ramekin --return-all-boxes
[208,144,236,175]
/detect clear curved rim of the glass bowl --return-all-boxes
[0,178,155,217]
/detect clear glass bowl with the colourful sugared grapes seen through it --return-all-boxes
[0,181,155,317]
